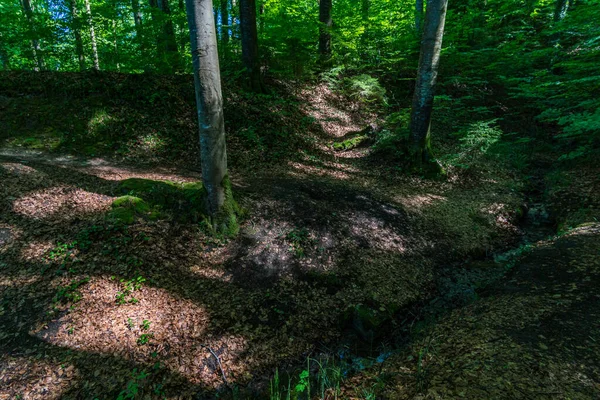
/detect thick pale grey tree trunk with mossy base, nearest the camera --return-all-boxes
[186,0,235,230]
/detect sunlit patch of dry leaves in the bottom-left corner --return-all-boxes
[0,354,78,400]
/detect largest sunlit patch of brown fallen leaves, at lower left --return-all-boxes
[35,277,246,388]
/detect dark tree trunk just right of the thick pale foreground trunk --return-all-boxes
[240,0,266,93]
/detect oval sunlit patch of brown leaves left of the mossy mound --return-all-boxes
[13,187,113,220]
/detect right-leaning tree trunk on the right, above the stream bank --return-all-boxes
[410,0,448,166]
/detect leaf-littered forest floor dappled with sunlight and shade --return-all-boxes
[0,73,600,398]
